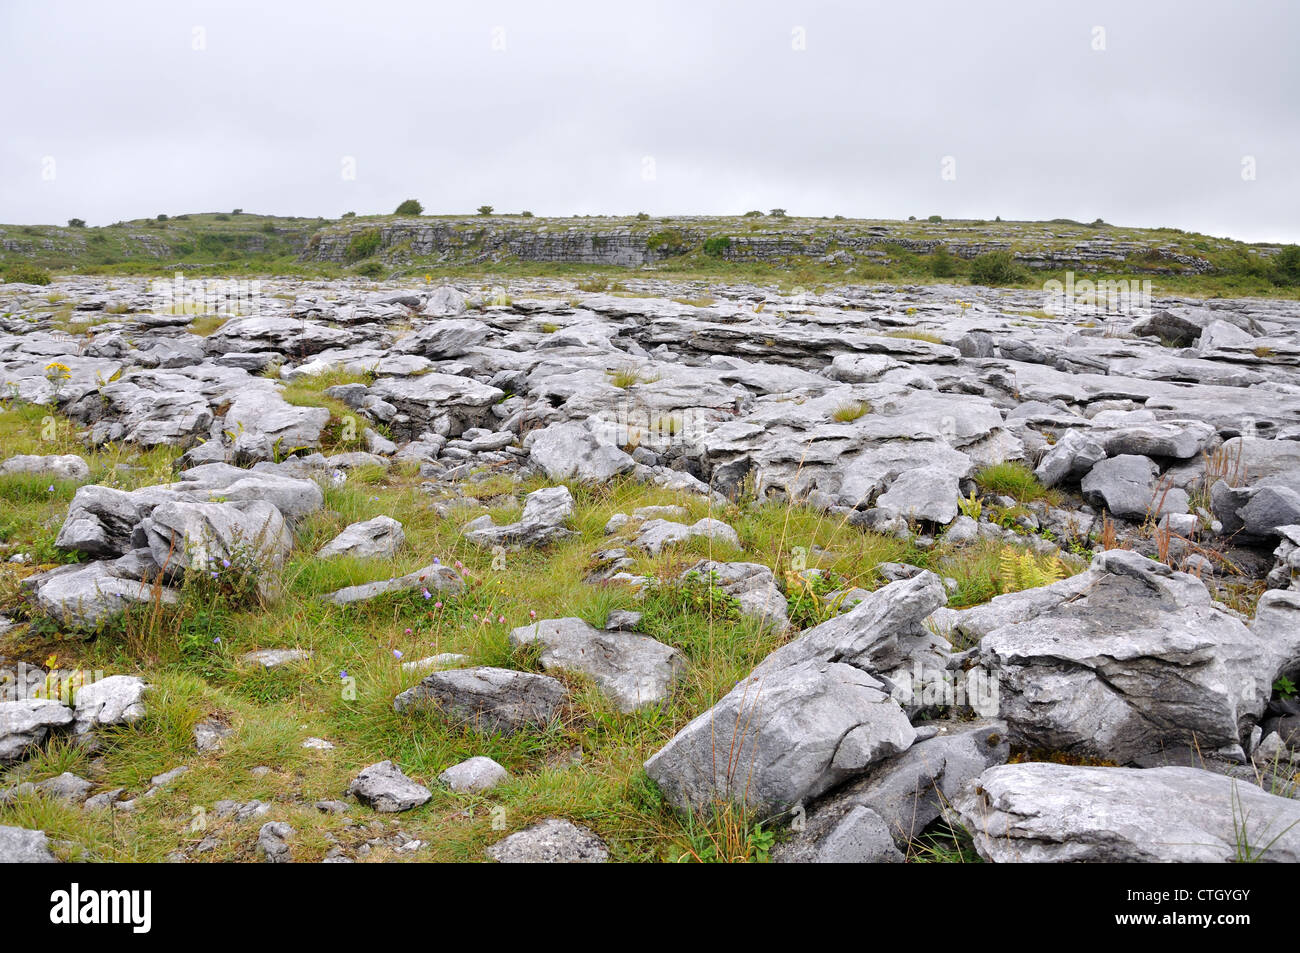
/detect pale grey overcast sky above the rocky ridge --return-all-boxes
[0,0,1300,242]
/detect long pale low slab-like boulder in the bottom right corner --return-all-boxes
[954,762,1300,863]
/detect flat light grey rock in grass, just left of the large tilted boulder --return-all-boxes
[510,618,686,711]
